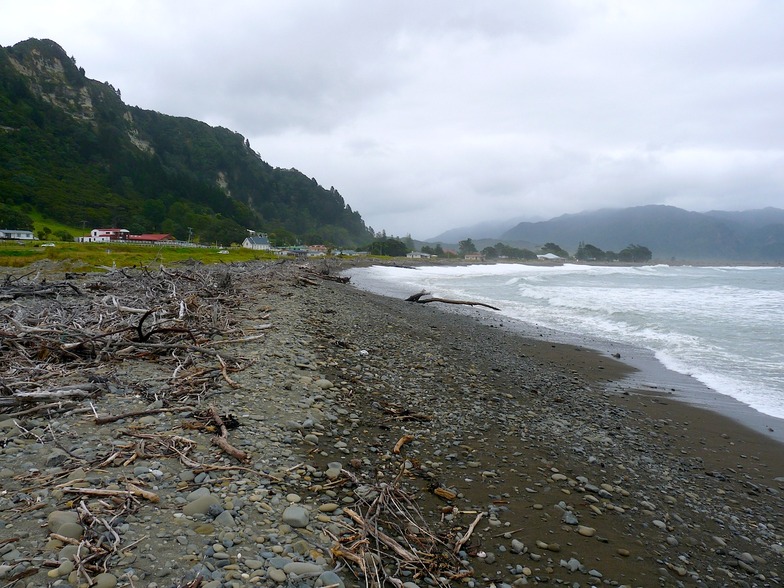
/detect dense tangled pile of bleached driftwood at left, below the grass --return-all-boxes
[0,267,268,416]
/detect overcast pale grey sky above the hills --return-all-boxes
[0,0,784,239]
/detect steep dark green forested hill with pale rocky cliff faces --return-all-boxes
[0,39,372,246]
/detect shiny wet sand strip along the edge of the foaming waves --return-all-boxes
[344,262,784,446]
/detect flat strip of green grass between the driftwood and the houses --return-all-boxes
[0,240,275,271]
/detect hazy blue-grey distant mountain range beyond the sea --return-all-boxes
[428,205,784,263]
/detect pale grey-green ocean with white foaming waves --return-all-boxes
[350,263,784,419]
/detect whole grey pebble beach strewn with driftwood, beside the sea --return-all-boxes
[0,263,784,588]
